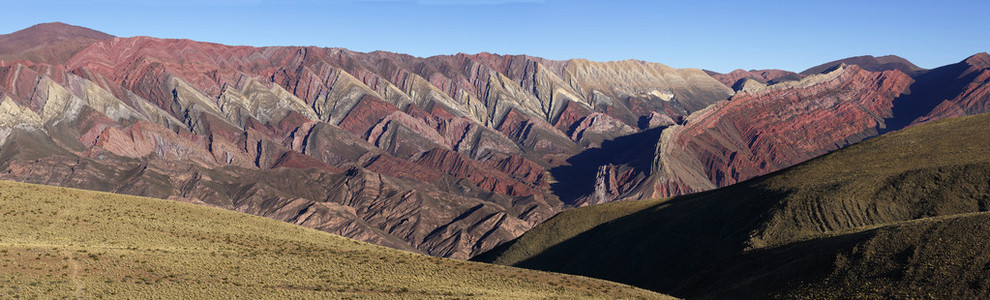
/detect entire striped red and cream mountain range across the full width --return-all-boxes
[0,23,990,259]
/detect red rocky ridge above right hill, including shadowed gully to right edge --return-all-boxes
[572,53,990,204]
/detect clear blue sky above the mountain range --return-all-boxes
[0,0,990,72]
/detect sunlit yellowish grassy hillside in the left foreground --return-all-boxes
[0,182,664,299]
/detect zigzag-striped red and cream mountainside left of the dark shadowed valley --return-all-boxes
[0,24,731,258]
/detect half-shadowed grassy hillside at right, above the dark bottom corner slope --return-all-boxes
[475,114,990,296]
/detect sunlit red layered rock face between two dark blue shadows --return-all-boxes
[644,66,912,198]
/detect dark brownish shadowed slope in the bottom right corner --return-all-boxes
[678,212,990,299]
